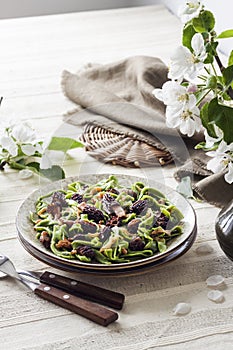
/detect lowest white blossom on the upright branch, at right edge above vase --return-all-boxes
[206,140,233,184]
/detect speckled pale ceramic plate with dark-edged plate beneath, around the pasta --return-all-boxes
[16,174,196,273]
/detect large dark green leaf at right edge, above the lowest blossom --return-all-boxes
[208,98,233,144]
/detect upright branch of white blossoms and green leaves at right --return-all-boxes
[152,0,233,184]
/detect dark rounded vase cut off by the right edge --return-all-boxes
[215,200,233,261]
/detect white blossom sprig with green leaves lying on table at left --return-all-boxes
[0,120,82,179]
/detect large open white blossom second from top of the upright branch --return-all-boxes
[168,33,207,81]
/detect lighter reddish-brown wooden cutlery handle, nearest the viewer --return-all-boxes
[35,283,118,326]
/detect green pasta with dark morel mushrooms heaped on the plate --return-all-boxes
[30,175,183,264]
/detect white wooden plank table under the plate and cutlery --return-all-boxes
[0,6,233,350]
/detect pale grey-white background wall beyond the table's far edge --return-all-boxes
[0,0,233,54]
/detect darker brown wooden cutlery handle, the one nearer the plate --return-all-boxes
[40,271,125,310]
